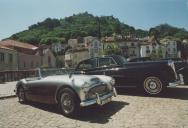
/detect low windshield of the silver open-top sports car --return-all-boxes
[39,68,74,77]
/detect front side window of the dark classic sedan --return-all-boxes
[99,58,116,67]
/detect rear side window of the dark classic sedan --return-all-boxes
[77,59,97,70]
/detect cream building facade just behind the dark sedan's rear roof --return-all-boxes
[65,49,90,68]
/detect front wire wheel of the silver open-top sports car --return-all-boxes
[59,88,80,117]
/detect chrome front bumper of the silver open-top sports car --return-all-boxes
[80,88,117,107]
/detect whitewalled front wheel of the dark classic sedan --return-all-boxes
[143,76,163,95]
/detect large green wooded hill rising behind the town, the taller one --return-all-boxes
[10,12,148,44]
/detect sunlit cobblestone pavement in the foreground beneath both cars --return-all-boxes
[0,87,188,128]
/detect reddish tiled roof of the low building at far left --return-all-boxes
[0,40,38,50]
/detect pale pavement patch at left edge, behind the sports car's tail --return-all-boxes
[0,81,17,98]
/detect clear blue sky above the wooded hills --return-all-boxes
[0,0,188,40]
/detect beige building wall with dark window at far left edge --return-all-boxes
[0,45,18,71]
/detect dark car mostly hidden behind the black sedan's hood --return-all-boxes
[128,57,188,85]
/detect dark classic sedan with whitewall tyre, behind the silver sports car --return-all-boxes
[75,55,181,95]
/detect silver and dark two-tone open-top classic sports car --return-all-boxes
[15,69,117,116]
